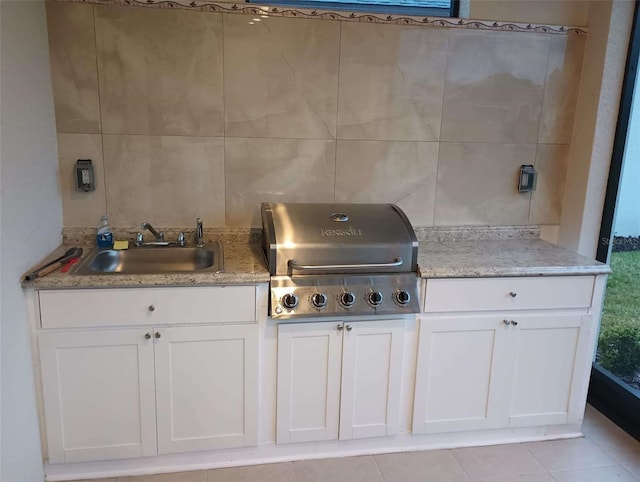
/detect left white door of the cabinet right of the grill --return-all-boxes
[413,316,511,434]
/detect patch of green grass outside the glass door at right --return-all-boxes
[602,251,640,328]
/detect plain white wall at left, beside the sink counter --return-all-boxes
[0,0,62,482]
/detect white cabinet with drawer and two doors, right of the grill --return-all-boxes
[413,276,594,433]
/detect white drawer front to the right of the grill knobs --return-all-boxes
[424,276,593,313]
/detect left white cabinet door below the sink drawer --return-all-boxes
[39,329,157,463]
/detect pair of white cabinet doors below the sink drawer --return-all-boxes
[39,289,258,463]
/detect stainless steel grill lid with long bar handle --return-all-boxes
[262,203,418,275]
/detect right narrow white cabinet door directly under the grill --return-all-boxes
[340,320,405,440]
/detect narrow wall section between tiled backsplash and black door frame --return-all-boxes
[558,0,635,258]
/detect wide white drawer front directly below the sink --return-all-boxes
[39,286,256,328]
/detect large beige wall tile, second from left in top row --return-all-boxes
[92,6,224,136]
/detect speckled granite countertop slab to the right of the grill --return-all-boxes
[418,239,611,278]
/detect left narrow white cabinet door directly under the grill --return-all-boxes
[276,322,343,443]
